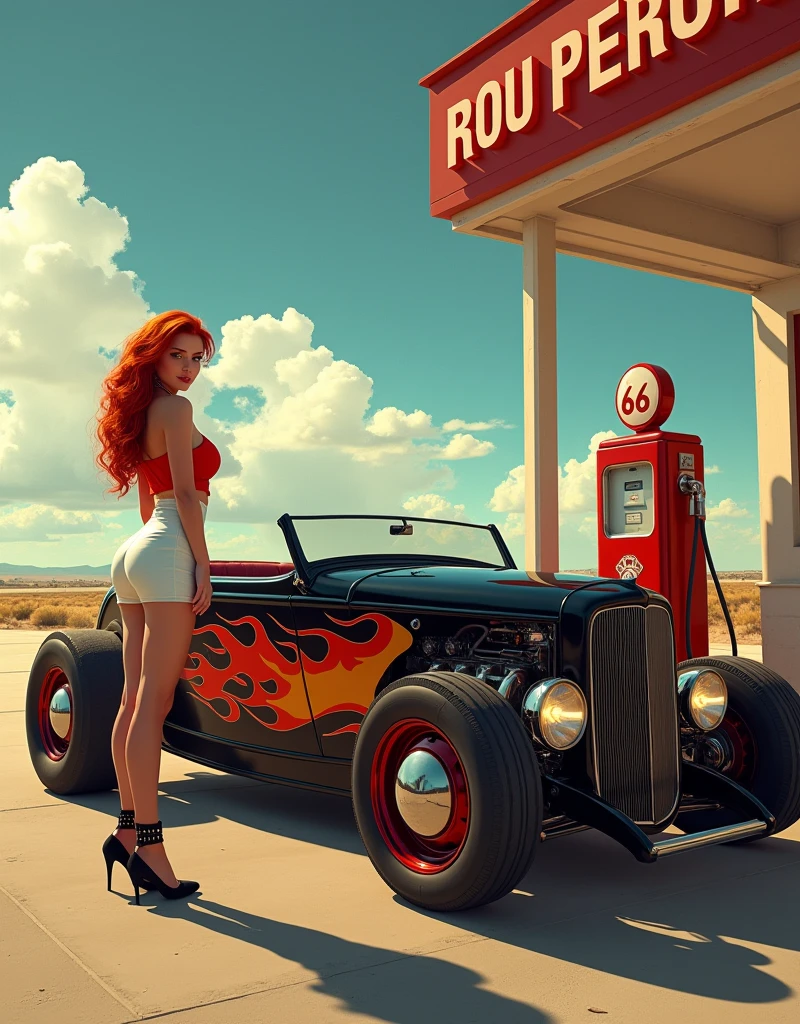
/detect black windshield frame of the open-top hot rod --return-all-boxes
[278,512,517,588]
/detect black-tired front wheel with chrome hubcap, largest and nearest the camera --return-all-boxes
[352,672,542,910]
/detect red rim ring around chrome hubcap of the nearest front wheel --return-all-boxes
[371,718,469,874]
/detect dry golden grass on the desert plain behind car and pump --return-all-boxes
[0,580,761,643]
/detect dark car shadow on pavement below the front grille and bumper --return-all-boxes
[405,833,800,1004]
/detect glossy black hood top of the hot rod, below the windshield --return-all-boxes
[310,565,646,618]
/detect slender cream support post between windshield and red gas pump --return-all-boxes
[522,217,558,572]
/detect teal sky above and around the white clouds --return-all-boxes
[0,0,761,568]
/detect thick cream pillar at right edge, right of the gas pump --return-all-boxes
[753,276,800,691]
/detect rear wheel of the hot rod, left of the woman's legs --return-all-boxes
[25,630,125,795]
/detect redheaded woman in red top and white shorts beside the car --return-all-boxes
[97,309,220,903]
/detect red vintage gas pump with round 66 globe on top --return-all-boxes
[597,362,736,662]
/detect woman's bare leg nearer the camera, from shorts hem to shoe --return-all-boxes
[125,601,196,886]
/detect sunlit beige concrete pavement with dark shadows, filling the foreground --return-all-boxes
[0,630,800,1024]
